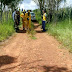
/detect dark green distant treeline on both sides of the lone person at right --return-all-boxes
[34,7,72,22]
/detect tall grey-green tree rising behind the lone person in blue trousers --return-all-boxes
[33,0,63,21]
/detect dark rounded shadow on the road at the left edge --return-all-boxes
[0,55,15,67]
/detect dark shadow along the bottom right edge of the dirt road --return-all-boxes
[30,66,72,72]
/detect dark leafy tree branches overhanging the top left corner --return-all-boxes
[0,0,22,21]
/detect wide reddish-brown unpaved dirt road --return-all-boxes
[0,23,72,72]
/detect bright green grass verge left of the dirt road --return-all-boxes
[0,19,15,41]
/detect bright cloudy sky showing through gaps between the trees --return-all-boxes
[19,0,72,10]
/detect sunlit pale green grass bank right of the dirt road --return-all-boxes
[47,19,72,52]
